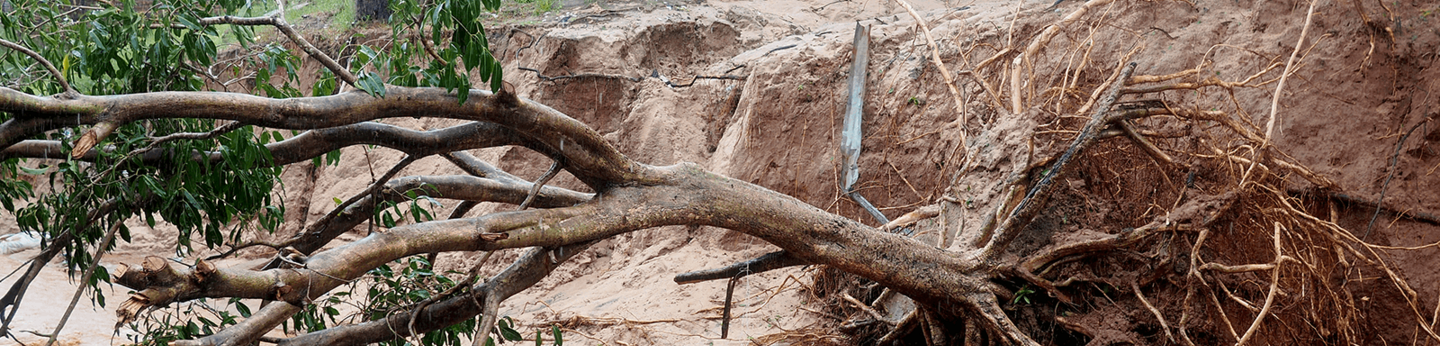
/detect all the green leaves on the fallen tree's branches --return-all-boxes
[0,0,515,345]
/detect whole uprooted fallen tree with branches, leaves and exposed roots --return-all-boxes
[0,0,1440,345]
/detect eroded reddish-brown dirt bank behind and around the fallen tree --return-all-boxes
[0,1,1440,345]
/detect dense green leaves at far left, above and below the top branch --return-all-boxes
[0,0,282,284]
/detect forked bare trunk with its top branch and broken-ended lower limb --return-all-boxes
[0,70,1048,346]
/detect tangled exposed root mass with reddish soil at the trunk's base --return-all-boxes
[816,0,1440,345]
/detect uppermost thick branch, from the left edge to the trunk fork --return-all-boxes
[0,87,642,187]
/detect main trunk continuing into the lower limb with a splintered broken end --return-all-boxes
[118,164,1025,346]
